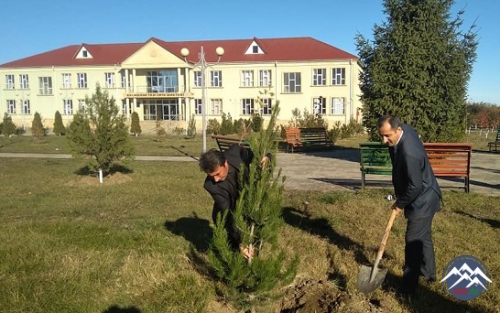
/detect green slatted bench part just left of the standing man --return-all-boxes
[359,142,392,188]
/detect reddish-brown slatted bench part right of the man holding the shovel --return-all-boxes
[424,142,472,193]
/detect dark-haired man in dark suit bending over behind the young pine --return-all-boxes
[199,144,271,258]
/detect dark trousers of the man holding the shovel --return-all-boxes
[403,215,436,292]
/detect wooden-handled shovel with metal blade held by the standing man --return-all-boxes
[358,210,398,294]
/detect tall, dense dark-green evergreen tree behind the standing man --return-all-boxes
[356,0,477,142]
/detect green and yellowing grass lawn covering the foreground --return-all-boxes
[0,132,500,313]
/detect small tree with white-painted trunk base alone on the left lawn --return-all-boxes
[67,84,134,175]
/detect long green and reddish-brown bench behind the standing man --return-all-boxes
[359,142,472,193]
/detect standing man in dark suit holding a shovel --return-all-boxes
[378,115,441,294]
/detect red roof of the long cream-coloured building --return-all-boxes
[0,37,358,68]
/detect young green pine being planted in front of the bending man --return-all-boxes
[208,99,298,308]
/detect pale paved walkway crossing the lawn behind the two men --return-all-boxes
[0,149,500,196]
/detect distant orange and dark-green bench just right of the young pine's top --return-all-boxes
[285,127,332,153]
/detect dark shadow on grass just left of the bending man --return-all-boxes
[164,215,213,252]
